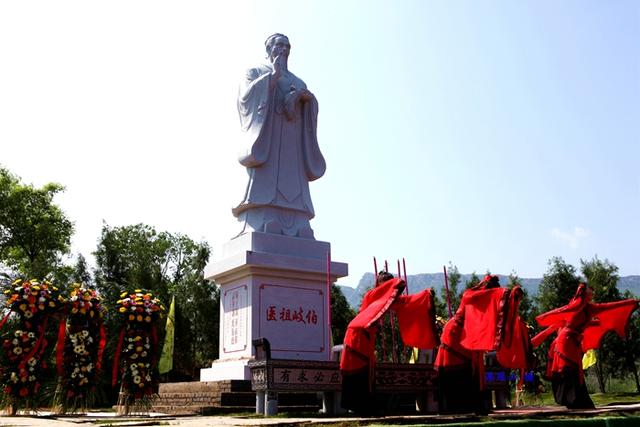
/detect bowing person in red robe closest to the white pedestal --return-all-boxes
[340,272,438,414]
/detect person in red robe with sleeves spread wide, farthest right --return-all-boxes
[531,283,638,409]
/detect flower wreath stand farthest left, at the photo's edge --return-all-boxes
[0,279,64,411]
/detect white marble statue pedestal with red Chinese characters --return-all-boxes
[200,232,348,381]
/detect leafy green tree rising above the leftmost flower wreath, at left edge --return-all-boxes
[0,167,73,278]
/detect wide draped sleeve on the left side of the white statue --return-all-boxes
[238,68,273,167]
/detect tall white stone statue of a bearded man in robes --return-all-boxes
[233,34,326,239]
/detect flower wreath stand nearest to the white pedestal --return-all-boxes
[112,289,165,404]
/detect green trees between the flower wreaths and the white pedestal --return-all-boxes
[94,224,214,380]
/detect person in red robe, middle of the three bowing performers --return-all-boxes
[434,275,531,414]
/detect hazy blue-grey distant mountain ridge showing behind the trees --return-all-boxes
[340,273,640,310]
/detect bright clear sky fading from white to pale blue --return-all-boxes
[0,0,640,285]
